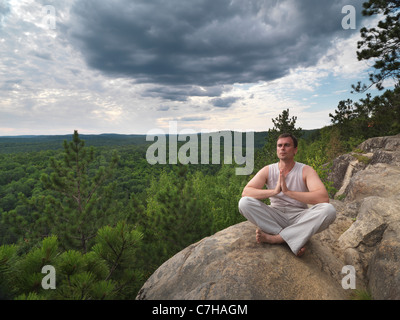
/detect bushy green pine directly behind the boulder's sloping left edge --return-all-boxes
[144,166,212,268]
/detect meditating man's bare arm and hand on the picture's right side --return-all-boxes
[280,166,329,204]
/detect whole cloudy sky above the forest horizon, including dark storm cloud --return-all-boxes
[0,0,388,136]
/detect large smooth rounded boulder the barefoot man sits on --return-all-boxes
[137,222,348,300]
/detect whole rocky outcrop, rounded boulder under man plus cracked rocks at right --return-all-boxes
[137,135,400,300]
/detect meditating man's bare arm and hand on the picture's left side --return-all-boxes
[242,166,281,200]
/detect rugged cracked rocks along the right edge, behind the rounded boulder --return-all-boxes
[324,135,400,299]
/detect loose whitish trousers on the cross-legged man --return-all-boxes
[239,197,336,254]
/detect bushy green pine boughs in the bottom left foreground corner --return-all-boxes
[0,222,142,300]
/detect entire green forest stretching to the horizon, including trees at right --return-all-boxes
[0,0,400,300]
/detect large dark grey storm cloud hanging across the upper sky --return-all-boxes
[66,0,362,87]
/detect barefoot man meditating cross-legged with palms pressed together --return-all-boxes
[239,133,336,257]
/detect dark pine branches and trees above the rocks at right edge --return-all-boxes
[329,0,400,144]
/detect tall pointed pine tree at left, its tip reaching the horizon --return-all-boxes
[41,131,118,253]
